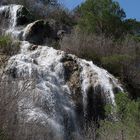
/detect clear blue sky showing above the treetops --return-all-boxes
[59,0,140,21]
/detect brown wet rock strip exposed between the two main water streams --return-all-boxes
[62,56,83,114]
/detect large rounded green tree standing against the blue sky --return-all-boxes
[75,0,125,38]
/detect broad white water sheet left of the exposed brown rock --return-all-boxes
[7,42,80,137]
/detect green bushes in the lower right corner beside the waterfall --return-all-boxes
[98,93,140,140]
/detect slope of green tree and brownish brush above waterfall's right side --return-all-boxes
[60,0,140,98]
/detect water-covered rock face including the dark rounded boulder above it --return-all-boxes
[0,6,123,140]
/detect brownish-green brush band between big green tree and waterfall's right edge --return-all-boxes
[60,28,140,98]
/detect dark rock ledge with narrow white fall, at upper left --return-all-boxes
[0,4,31,28]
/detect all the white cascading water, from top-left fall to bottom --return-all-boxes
[0,5,123,140]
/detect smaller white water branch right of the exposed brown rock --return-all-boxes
[79,60,123,116]
